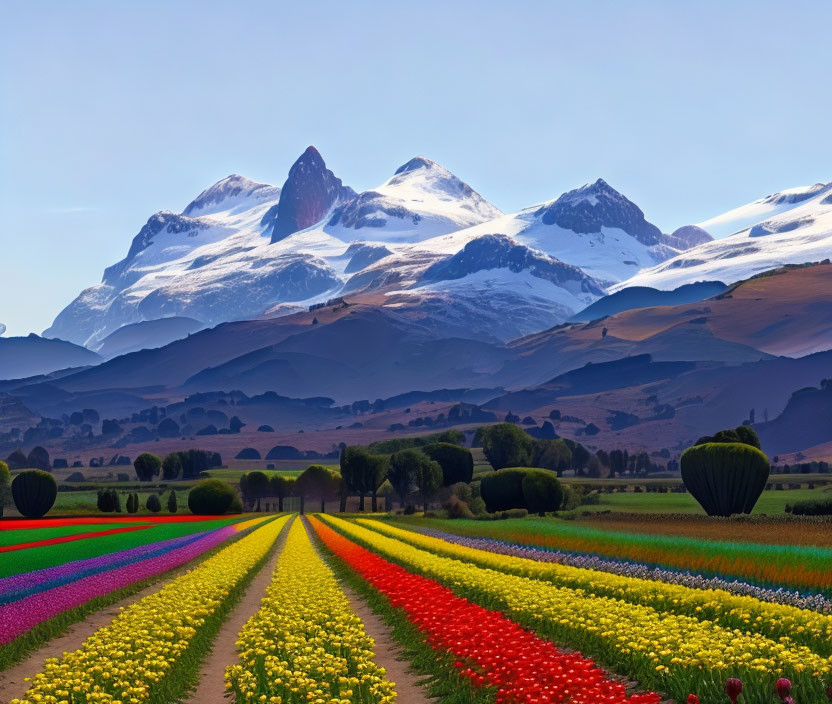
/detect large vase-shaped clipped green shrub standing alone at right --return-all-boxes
[681,442,769,516]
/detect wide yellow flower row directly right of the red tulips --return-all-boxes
[325,516,832,704]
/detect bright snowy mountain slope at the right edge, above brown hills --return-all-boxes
[614,183,832,290]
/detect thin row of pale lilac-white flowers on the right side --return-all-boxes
[417,526,832,614]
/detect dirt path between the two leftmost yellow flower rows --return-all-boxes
[183,518,295,704]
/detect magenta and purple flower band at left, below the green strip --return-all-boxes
[0,525,237,644]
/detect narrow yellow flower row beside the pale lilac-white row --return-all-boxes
[357,519,832,655]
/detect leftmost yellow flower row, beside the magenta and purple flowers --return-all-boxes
[11,516,288,704]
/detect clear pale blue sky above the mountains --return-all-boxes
[0,0,832,335]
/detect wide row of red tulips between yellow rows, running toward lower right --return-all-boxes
[311,518,660,704]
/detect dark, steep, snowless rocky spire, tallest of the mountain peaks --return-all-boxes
[262,146,355,243]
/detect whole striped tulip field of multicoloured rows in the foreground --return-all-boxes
[0,514,832,704]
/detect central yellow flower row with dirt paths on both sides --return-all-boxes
[225,520,396,704]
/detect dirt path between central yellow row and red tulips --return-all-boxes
[304,519,435,704]
